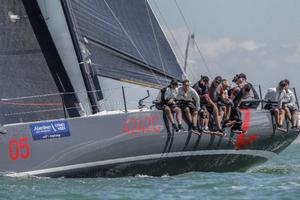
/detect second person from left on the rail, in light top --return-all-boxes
[177,80,200,130]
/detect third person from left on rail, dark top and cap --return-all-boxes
[193,76,209,132]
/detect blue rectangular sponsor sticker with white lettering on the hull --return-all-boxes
[30,120,70,140]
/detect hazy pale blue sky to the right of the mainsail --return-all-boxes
[148,0,300,95]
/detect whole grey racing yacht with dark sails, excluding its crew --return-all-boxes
[0,0,299,177]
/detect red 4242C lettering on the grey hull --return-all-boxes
[123,115,161,135]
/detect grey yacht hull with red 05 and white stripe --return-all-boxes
[0,110,299,177]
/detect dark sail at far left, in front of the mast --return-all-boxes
[0,0,78,124]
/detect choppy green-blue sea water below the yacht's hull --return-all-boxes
[0,144,300,200]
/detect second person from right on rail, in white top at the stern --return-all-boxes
[264,81,287,131]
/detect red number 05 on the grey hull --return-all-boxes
[8,137,30,160]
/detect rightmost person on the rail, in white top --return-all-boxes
[279,79,298,129]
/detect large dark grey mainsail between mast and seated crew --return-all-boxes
[62,0,182,85]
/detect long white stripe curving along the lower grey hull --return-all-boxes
[7,150,277,177]
